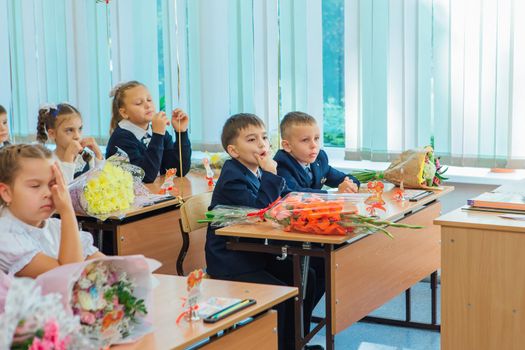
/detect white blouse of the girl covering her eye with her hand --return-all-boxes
[0,208,98,275]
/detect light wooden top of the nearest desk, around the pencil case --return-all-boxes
[141,275,297,349]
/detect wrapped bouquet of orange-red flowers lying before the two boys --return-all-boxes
[200,192,422,238]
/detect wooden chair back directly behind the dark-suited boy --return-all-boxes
[177,192,212,276]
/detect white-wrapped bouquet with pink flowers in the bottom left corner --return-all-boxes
[0,272,93,350]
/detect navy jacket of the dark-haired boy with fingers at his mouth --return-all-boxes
[205,159,285,278]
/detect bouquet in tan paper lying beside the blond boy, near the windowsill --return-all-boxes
[350,146,448,189]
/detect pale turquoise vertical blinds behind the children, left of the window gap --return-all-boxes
[0,0,323,150]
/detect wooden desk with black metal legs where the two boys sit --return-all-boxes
[216,184,453,350]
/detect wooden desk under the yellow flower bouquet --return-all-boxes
[77,173,211,275]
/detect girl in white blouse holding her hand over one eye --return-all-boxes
[0,144,104,278]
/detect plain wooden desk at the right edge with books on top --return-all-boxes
[434,209,525,350]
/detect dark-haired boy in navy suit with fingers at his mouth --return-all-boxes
[205,113,319,349]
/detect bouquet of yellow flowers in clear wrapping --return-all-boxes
[69,149,172,220]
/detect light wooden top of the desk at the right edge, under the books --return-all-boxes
[434,208,525,233]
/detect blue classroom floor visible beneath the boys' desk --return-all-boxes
[310,282,441,350]
